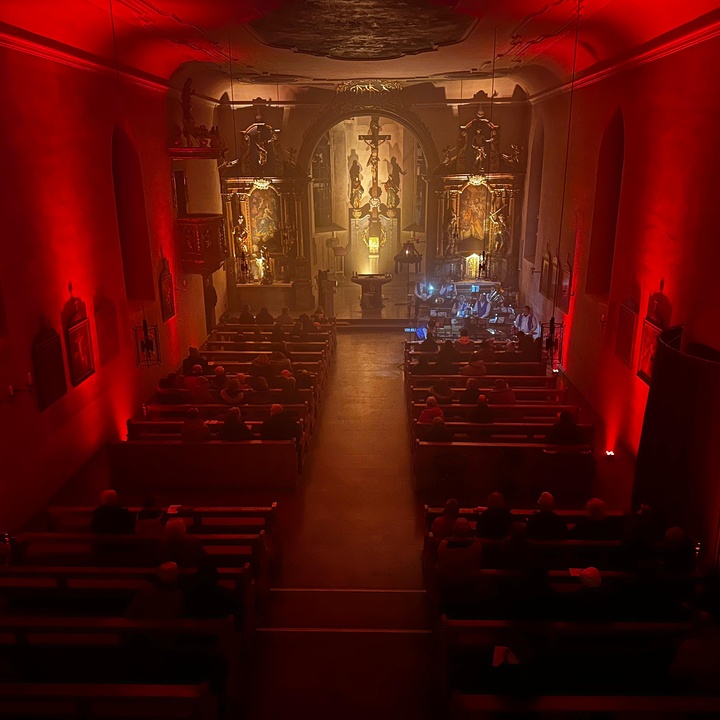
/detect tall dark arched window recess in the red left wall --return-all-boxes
[112,127,155,300]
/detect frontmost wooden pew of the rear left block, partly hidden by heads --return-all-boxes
[46,502,277,533]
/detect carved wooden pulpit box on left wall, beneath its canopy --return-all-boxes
[175,213,227,273]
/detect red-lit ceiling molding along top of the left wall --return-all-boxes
[0,23,170,93]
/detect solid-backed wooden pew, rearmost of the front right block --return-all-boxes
[413,440,595,505]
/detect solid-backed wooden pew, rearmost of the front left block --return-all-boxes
[108,440,300,494]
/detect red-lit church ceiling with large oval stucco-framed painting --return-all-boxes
[0,0,720,97]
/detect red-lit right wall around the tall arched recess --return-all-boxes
[522,39,720,478]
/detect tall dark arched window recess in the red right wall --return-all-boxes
[585,110,625,295]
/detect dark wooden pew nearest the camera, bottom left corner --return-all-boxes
[0,682,217,720]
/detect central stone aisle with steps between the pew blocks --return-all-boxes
[249,331,436,720]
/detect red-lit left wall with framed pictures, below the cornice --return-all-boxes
[0,48,204,528]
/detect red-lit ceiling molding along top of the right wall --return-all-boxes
[530,13,720,105]
